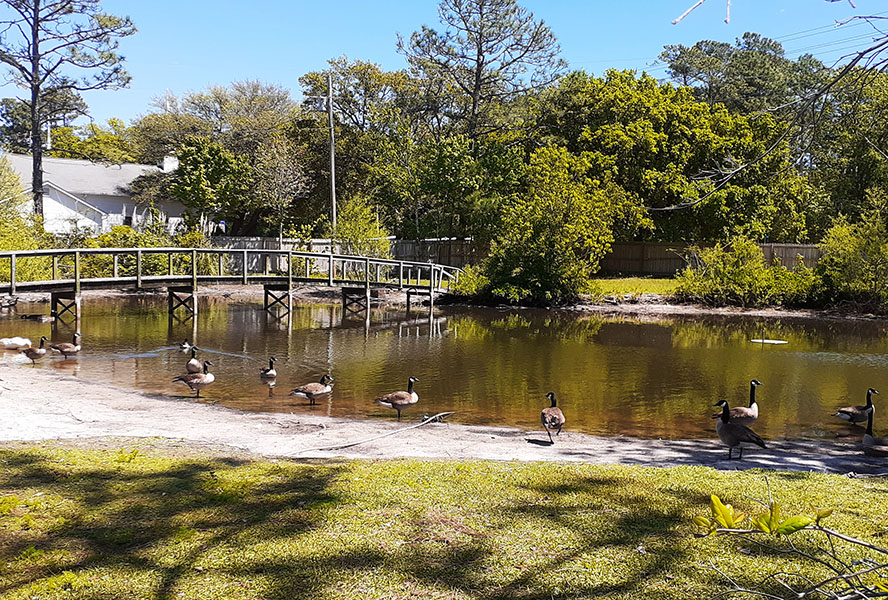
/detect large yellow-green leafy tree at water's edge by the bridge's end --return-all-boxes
[486,147,640,303]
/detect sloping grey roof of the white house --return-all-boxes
[4,153,160,196]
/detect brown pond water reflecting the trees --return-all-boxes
[0,297,888,439]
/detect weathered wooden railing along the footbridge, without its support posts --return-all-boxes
[0,248,461,294]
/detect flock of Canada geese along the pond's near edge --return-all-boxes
[0,332,888,460]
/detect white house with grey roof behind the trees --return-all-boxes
[4,153,185,233]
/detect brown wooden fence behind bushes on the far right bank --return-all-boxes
[599,242,820,277]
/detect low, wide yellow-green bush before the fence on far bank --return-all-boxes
[676,237,817,306]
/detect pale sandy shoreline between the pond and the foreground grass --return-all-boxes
[0,362,888,474]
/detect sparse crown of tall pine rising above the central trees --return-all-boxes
[398,0,566,141]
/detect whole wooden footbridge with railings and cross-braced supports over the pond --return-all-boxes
[0,248,461,318]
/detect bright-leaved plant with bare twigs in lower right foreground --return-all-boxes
[694,494,888,600]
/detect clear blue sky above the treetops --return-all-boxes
[2,0,888,121]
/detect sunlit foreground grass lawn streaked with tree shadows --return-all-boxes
[0,445,888,600]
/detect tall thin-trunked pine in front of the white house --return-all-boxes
[0,0,136,215]
